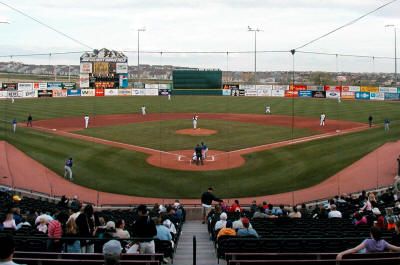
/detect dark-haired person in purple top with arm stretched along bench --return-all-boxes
[336,227,400,260]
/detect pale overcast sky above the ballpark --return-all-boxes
[0,0,400,72]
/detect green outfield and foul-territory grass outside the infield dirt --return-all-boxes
[0,96,400,198]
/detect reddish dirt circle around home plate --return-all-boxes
[146,150,246,171]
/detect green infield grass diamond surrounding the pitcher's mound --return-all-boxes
[76,120,317,151]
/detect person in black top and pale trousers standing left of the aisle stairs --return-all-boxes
[134,204,157,254]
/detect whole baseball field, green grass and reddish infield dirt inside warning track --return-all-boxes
[0,96,400,198]
